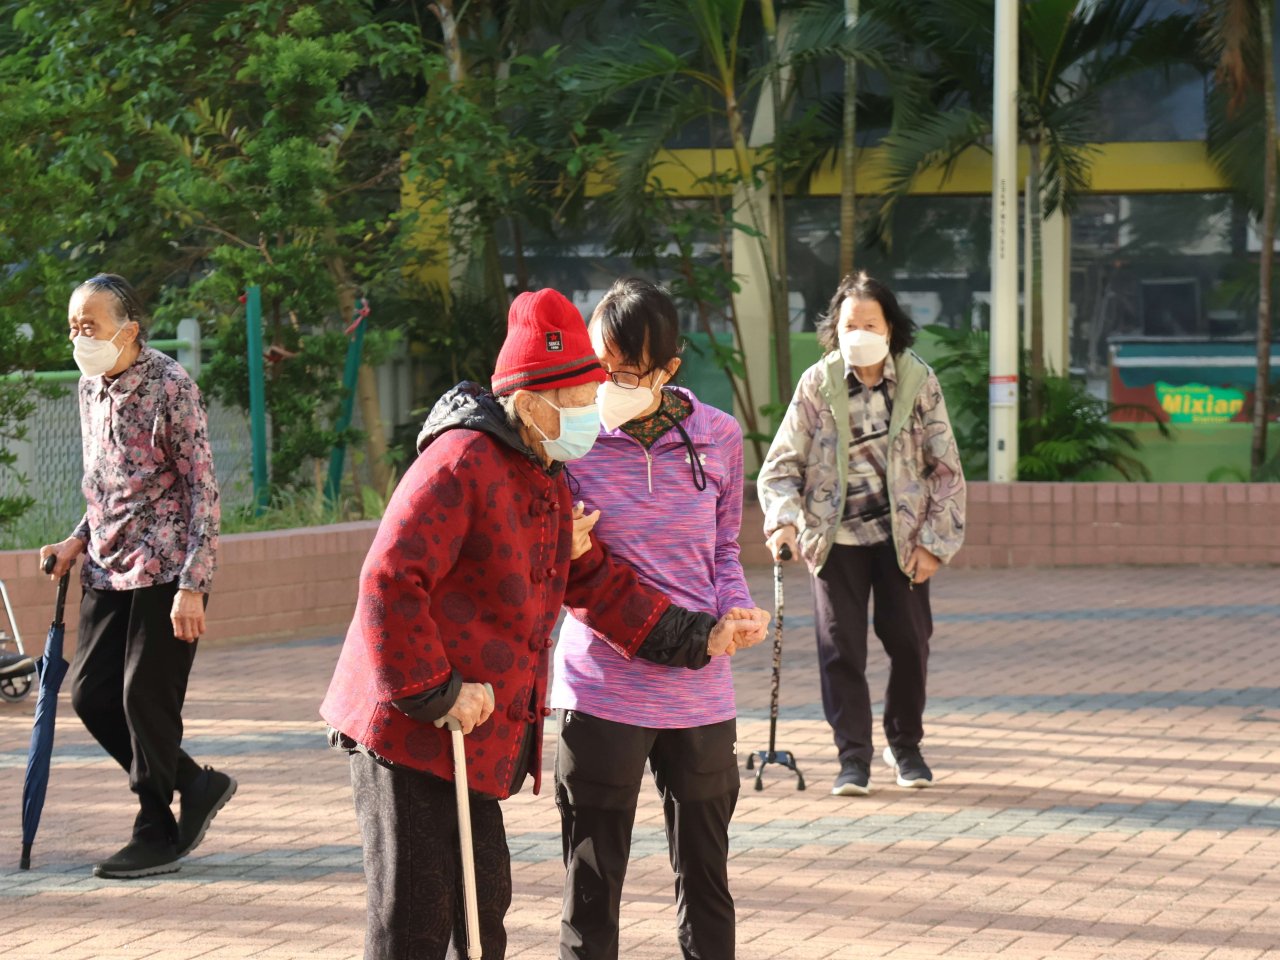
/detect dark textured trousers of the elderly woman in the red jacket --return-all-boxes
[351,751,511,960]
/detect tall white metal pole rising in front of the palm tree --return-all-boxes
[989,0,1019,483]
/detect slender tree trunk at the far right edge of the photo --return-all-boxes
[1249,0,1277,480]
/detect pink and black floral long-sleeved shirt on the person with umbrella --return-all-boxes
[73,347,220,593]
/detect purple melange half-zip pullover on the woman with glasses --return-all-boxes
[550,390,754,730]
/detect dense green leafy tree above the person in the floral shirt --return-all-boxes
[0,0,435,504]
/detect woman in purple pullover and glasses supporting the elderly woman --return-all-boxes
[550,279,755,960]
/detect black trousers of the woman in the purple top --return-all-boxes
[556,710,739,960]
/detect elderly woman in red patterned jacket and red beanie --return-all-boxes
[320,291,768,960]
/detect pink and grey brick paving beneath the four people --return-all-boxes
[0,568,1280,960]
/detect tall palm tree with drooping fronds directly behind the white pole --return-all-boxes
[878,0,1197,413]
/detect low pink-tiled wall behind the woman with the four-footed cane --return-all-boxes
[741,484,1280,568]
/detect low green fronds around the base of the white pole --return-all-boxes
[927,326,1169,480]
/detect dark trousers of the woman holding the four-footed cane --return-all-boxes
[813,544,933,763]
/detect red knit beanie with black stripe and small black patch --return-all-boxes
[493,289,604,397]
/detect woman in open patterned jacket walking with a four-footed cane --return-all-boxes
[758,274,965,796]
